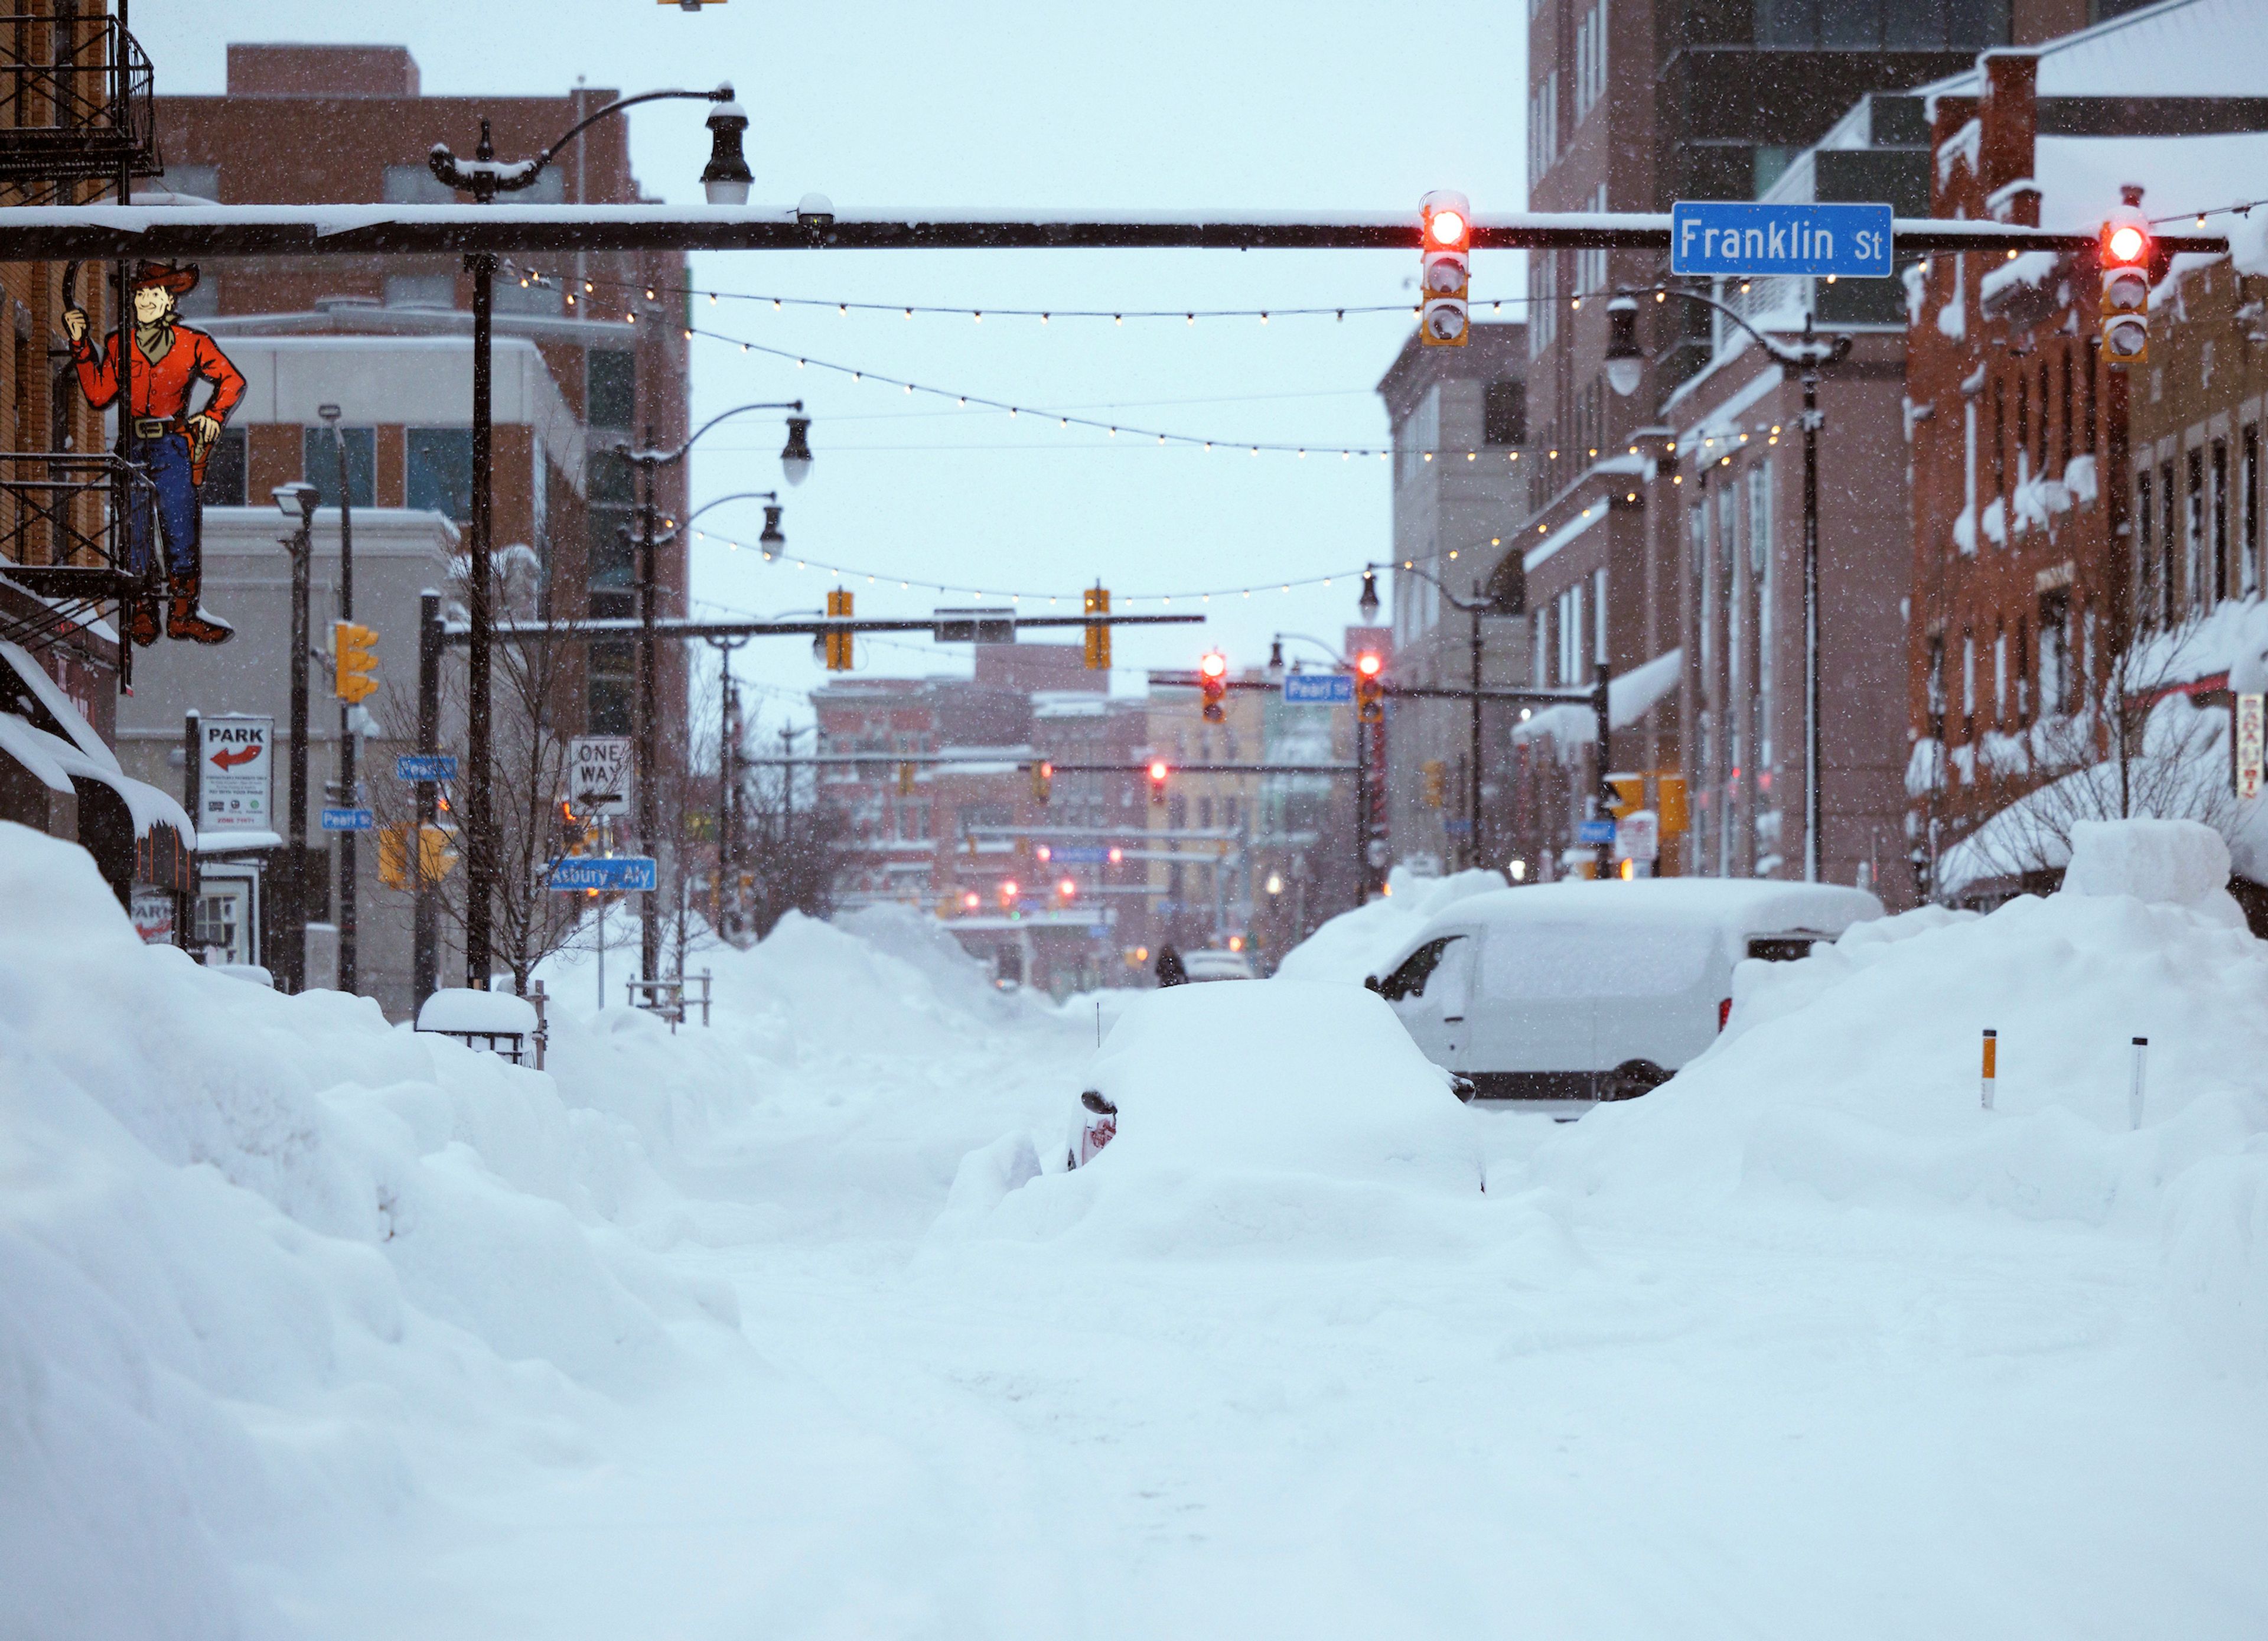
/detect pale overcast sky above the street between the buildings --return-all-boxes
[132,0,1526,717]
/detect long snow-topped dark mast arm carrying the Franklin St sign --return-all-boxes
[0,202,2230,261]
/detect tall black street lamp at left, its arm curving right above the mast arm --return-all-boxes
[426,86,748,992]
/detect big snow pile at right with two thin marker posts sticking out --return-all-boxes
[1536,822,2268,1364]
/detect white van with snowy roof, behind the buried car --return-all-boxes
[1363,878,1882,1101]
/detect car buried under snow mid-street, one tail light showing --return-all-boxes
[1066,981,1481,1191]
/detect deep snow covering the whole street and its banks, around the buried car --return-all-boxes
[0,833,2268,1636]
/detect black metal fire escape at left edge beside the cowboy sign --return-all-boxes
[0,0,163,683]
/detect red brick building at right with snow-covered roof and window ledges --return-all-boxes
[1907,16,2268,894]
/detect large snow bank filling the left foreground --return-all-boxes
[0,824,737,1636]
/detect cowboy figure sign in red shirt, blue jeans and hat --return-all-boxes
[64,261,245,644]
